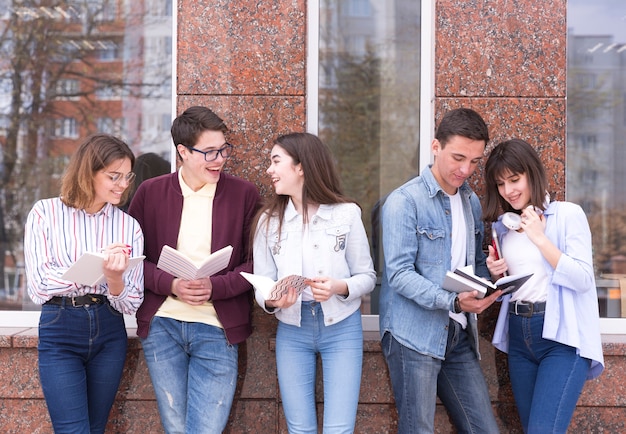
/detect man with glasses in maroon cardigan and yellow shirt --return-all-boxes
[129,106,260,433]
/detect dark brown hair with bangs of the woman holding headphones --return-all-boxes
[483,139,548,221]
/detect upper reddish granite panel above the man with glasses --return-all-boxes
[177,0,306,96]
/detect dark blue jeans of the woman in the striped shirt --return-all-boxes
[38,303,128,434]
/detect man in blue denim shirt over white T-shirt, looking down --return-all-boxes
[380,108,501,434]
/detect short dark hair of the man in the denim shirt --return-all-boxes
[435,108,489,148]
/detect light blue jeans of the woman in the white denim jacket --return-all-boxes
[276,301,363,434]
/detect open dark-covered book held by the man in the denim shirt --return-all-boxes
[441,265,533,298]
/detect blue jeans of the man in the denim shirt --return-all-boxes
[382,319,499,434]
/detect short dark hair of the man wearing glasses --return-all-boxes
[171,106,228,158]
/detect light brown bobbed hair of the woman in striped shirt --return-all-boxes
[61,134,135,209]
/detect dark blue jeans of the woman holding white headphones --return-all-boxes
[509,314,591,433]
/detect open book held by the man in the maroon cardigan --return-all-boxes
[157,245,233,280]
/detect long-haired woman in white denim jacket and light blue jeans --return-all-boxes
[252,133,376,434]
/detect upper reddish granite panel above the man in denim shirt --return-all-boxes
[435,0,567,98]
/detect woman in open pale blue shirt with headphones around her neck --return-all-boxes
[484,139,604,433]
